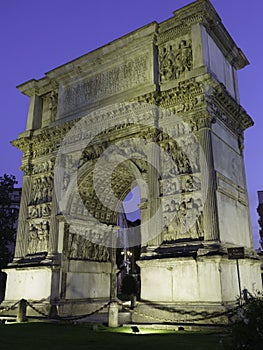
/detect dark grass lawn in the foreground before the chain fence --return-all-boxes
[0,322,231,350]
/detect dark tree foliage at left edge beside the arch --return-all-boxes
[0,174,18,269]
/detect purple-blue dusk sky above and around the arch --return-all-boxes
[0,0,263,246]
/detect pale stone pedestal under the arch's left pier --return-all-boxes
[4,260,111,316]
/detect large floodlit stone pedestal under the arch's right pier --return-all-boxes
[133,255,262,323]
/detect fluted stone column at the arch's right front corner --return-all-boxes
[196,114,219,241]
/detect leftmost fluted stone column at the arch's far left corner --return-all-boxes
[14,175,32,260]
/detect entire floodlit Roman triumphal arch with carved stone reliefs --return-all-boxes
[5,0,261,322]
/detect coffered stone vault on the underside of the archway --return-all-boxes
[66,156,147,246]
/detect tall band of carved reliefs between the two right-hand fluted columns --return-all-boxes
[158,120,204,242]
